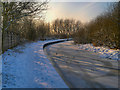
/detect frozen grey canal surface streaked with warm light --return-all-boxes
[45,41,119,88]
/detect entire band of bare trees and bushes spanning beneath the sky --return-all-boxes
[2,1,120,51]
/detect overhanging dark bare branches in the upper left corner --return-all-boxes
[2,1,48,31]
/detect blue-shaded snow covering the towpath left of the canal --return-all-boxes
[2,39,68,88]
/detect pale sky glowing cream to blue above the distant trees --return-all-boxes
[45,2,110,23]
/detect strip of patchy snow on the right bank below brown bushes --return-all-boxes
[78,44,120,60]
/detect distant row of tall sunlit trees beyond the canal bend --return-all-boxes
[51,19,83,38]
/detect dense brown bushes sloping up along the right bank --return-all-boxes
[73,2,120,49]
